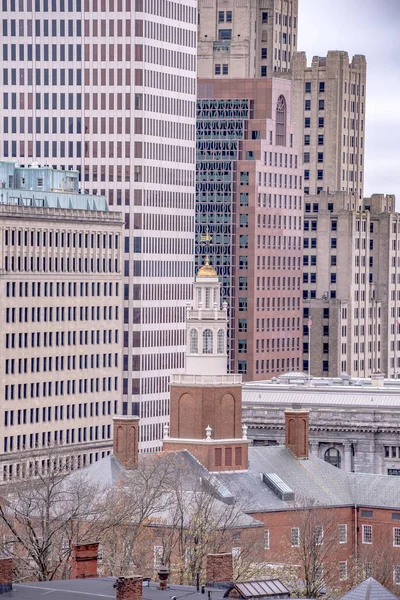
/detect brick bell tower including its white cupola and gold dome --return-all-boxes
[163,257,250,471]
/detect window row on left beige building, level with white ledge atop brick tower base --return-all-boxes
[4,377,118,400]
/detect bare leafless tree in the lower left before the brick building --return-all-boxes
[0,452,104,581]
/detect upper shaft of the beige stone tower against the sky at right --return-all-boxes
[281,51,366,200]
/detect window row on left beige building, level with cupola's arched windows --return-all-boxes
[6,329,119,349]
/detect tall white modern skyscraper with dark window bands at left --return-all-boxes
[0,0,197,451]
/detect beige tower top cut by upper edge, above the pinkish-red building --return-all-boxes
[198,0,298,79]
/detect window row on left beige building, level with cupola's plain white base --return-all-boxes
[4,353,118,375]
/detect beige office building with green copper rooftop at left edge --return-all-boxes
[0,163,123,482]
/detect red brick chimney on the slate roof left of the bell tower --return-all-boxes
[113,415,139,469]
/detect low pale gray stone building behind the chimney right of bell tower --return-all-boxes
[243,373,400,476]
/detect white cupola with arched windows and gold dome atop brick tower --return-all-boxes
[185,256,228,375]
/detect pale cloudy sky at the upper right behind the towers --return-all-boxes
[297,0,400,202]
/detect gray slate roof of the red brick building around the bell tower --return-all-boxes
[76,446,400,512]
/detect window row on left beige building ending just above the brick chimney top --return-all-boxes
[4,400,118,427]
